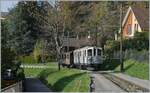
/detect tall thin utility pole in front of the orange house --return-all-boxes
[120,3,124,72]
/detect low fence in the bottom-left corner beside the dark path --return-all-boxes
[1,81,23,92]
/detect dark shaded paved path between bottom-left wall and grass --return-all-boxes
[25,78,51,92]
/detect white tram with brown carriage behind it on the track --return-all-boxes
[62,46,103,69]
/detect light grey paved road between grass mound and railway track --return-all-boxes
[92,73,124,92]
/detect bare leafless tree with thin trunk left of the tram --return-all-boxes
[27,1,64,70]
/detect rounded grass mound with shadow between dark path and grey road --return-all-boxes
[40,68,90,92]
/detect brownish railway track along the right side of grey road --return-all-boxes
[103,73,149,92]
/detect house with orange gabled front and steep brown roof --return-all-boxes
[122,7,149,38]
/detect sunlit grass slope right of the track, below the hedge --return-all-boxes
[115,60,149,80]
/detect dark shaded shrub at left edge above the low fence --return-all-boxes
[1,47,24,83]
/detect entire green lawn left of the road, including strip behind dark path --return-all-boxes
[24,63,90,92]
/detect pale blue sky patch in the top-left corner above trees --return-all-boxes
[0,0,55,12]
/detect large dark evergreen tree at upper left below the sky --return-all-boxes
[8,1,51,55]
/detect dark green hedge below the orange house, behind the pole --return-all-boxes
[105,32,149,54]
